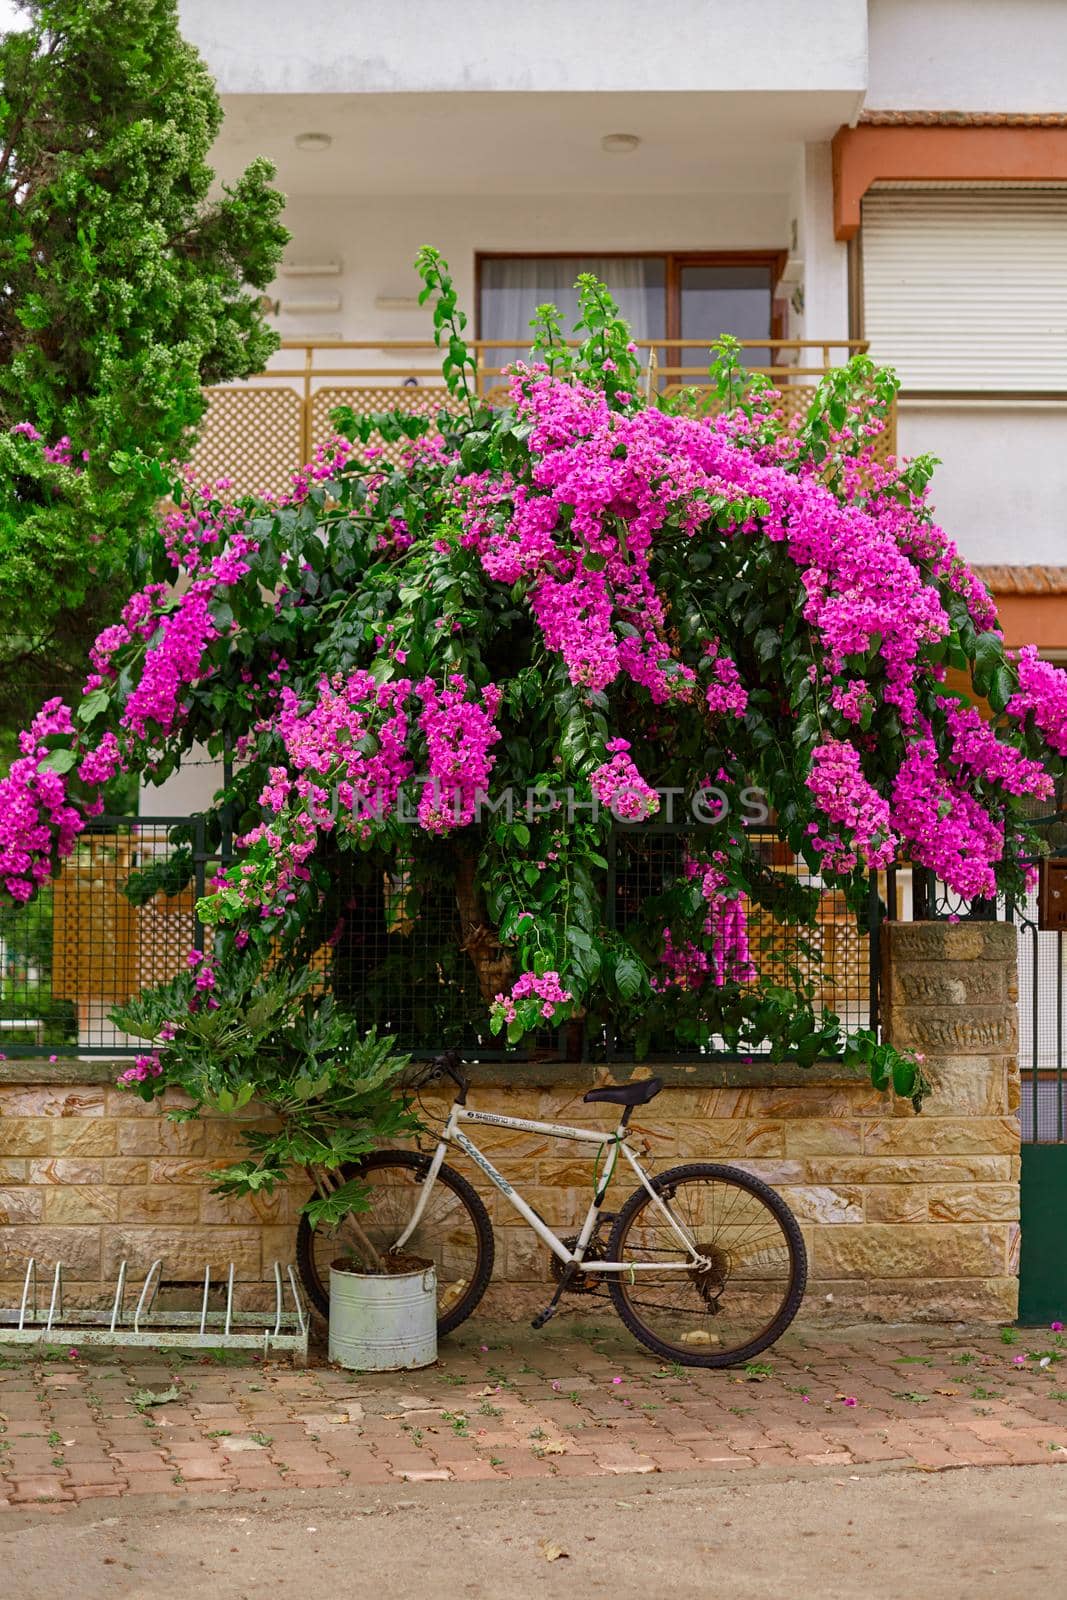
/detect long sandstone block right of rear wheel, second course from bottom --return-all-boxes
[813,1222,1008,1278]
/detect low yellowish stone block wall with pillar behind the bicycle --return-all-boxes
[0,923,1019,1322]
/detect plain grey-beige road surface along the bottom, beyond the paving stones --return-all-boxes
[0,1467,1067,1600]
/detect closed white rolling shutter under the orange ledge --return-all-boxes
[862,187,1067,392]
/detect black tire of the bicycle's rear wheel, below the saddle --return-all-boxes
[608,1162,808,1368]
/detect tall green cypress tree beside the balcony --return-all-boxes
[0,0,288,726]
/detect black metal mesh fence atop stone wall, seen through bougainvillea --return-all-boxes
[0,816,897,1059]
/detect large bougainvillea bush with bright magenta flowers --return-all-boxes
[0,250,1067,1113]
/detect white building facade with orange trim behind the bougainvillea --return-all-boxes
[181,0,1067,665]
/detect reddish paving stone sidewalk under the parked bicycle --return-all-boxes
[0,1322,1067,1510]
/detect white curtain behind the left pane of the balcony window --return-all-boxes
[480,256,667,355]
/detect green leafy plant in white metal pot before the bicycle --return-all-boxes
[114,933,437,1371]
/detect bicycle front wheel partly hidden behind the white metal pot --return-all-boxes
[296,1150,494,1334]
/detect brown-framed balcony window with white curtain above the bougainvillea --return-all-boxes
[477,253,784,366]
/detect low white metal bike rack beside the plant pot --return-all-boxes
[0,1258,309,1360]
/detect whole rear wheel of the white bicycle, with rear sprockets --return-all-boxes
[608,1162,808,1366]
